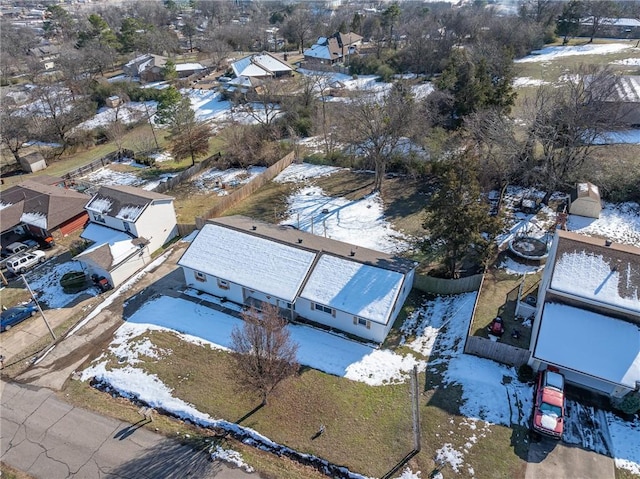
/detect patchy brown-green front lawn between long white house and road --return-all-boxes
[69,318,524,479]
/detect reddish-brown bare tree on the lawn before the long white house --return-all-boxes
[231,303,298,405]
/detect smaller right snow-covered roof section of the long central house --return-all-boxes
[300,254,404,324]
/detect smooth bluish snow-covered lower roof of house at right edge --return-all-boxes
[533,303,640,389]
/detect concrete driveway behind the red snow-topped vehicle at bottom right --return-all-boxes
[525,438,615,479]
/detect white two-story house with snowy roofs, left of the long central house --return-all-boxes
[75,186,178,286]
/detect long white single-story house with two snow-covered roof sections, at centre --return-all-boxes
[178,216,416,343]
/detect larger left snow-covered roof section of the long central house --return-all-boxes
[178,224,316,302]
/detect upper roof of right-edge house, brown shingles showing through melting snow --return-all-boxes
[550,231,640,314]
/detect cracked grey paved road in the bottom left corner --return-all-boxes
[0,381,258,479]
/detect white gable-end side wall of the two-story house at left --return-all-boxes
[131,200,178,251]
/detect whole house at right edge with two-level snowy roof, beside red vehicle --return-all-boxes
[529,230,640,397]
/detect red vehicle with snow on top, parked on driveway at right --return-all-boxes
[532,369,565,439]
